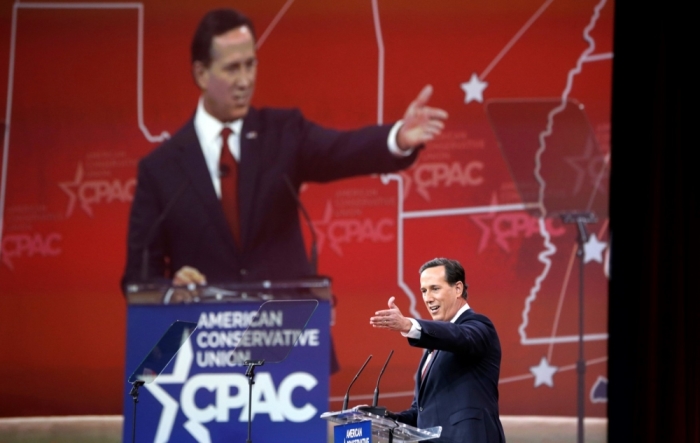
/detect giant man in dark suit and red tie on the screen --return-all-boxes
[123,9,447,285]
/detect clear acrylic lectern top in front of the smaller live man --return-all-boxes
[321,406,442,443]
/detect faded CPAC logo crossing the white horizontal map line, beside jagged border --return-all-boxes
[471,212,566,252]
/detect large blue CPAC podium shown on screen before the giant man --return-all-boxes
[123,278,331,443]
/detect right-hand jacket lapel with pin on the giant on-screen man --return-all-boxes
[238,108,264,249]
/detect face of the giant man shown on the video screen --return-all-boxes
[192,26,257,122]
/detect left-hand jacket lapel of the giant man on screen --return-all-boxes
[176,120,236,248]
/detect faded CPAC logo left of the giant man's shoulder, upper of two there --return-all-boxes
[58,163,136,218]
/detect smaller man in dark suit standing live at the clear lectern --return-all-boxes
[370,258,505,443]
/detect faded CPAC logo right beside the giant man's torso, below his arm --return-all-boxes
[313,201,396,257]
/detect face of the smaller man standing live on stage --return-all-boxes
[420,266,465,321]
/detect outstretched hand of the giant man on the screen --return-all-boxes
[396,85,447,150]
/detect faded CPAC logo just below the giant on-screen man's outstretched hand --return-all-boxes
[401,160,484,201]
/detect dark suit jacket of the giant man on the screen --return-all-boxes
[123,108,416,283]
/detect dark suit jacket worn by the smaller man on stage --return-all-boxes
[396,309,505,443]
